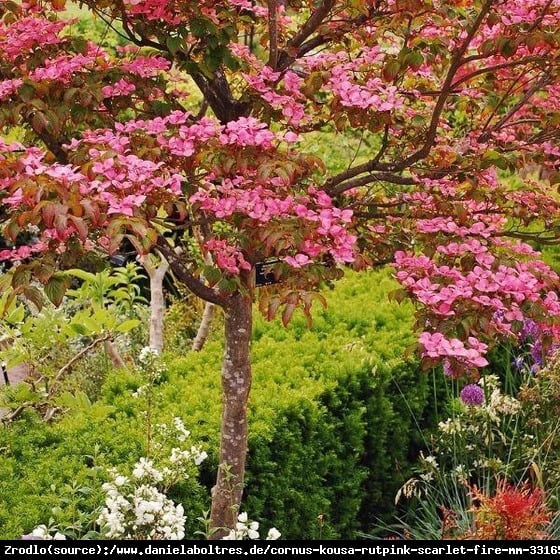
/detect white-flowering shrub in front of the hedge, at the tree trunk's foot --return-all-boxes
[22,347,280,540]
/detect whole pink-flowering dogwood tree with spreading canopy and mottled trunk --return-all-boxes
[0,0,560,536]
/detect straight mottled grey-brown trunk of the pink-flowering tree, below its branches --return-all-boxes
[210,293,252,539]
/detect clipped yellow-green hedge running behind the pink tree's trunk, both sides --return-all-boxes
[0,272,444,539]
